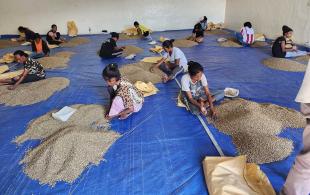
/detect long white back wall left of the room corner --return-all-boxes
[0,0,226,34]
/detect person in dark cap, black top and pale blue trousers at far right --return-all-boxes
[272,25,309,58]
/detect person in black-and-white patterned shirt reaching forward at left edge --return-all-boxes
[0,50,45,90]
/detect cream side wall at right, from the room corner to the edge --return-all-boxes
[225,0,310,44]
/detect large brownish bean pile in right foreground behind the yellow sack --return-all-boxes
[208,98,306,164]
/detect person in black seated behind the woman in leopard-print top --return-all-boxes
[99,32,125,58]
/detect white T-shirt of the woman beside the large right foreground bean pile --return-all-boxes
[181,73,208,94]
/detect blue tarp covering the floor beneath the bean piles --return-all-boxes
[0,30,304,194]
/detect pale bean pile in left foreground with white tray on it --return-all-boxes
[14,105,120,186]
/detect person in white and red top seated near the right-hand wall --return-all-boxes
[236,22,255,46]
